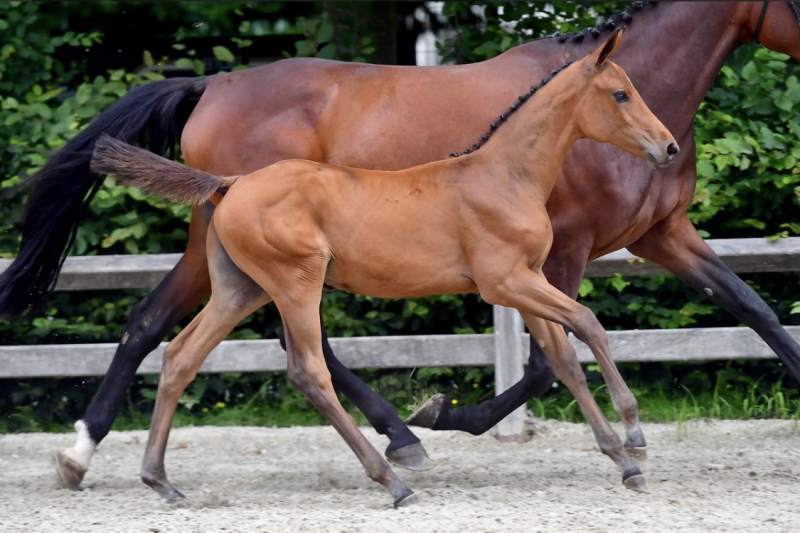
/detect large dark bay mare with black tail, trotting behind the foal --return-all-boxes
[0,2,800,488]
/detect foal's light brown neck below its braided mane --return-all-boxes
[472,68,581,200]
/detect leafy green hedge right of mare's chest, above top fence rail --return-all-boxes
[691,48,800,236]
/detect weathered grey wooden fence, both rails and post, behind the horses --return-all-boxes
[0,237,800,435]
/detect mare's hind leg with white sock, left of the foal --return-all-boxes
[56,203,214,490]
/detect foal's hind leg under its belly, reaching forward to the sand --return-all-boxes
[275,294,417,507]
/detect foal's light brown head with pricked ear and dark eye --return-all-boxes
[573,28,679,168]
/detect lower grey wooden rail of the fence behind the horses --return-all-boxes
[0,326,800,378]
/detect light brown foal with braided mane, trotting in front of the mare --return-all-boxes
[92,30,678,506]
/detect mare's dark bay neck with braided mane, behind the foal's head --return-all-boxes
[515,2,752,141]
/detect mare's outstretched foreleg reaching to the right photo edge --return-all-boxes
[628,214,800,383]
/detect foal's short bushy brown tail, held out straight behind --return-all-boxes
[91,135,236,204]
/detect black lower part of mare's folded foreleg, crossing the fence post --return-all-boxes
[432,338,555,435]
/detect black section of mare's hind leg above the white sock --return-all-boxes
[81,270,207,443]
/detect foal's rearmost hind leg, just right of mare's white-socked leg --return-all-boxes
[141,224,270,501]
